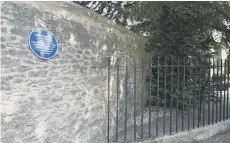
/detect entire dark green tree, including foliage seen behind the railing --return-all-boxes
[126,1,230,109]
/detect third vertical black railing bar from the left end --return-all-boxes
[125,58,128,141]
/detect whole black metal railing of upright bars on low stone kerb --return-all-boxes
[107,57,230,142]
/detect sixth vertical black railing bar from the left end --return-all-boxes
[149,56,152,138]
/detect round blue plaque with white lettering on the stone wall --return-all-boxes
[29,28,58,59]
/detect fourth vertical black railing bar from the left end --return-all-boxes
[134,58,137,140]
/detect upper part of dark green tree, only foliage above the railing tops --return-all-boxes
[128,1,230,56]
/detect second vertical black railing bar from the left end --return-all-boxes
[116,58,120,142]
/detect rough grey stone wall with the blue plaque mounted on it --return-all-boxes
[1,2,145,143]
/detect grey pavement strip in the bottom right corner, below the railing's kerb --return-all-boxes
[194,130,230,143]
